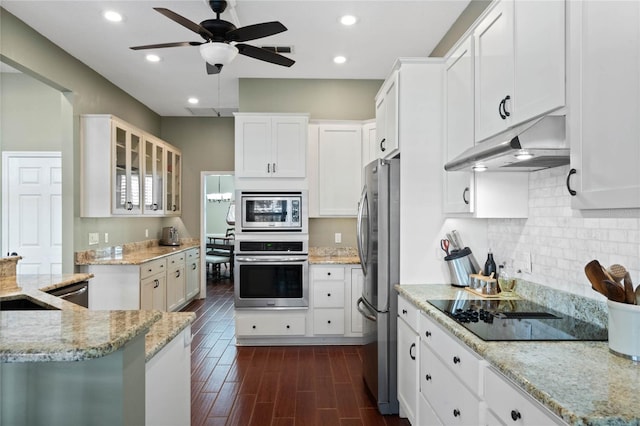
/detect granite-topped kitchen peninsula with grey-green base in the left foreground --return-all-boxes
[0,273,195,425]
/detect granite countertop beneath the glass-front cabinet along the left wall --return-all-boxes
[75,239,200,265]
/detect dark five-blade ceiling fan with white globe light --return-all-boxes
[131,0,295,74]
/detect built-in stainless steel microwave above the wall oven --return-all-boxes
[236,191,309,233]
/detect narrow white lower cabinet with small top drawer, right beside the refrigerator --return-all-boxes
[398,296,420,424]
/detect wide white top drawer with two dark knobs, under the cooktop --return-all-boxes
[419,314,485,396]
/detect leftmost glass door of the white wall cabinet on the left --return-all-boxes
[111,120,142,215]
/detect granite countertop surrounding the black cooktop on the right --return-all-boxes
[395,285,640,425]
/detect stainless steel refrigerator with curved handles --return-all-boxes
[357,159,400,414]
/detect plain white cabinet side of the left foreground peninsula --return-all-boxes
[145,326,191,426]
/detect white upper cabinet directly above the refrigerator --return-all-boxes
[375,70,400,158]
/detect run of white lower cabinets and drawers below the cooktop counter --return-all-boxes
[398,295,566,426]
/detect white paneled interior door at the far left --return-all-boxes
[2,152,62,274]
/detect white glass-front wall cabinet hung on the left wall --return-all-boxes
[80,114,181,217]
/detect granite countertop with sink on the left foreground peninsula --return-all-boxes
[0,273,196,362]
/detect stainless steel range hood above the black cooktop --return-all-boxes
[444,115,569,172]
